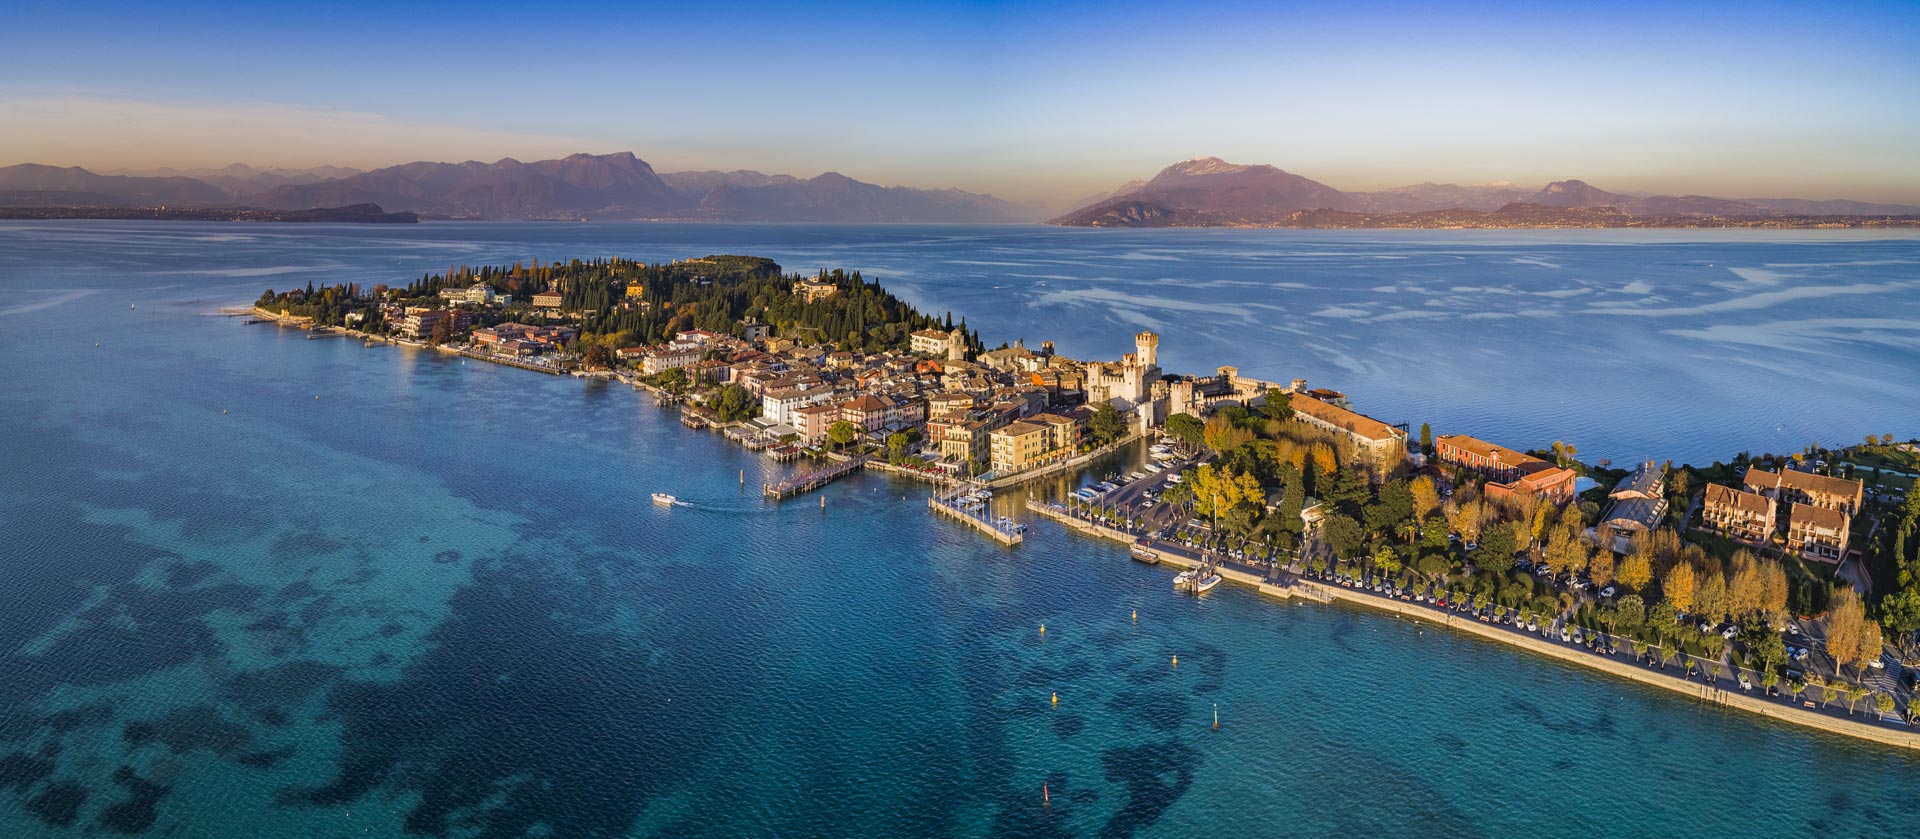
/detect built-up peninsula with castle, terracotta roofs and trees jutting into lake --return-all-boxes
[234,255,1920,749]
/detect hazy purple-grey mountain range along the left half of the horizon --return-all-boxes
[0,152,1048,223]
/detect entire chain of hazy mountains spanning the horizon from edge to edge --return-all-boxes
[0,152,1920,227]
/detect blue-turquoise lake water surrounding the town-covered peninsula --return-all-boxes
[0,223,1920,837]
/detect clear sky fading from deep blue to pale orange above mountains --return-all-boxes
[0,0,1920,204]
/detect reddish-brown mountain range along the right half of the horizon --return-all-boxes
[1050,157,1920,227]
